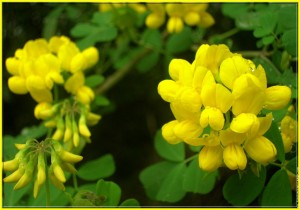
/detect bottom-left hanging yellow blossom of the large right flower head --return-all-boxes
[199,146,223,172]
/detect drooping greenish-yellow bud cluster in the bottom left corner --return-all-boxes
[3,140,82,198]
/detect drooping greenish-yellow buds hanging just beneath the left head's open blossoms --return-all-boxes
[34,99,101,151]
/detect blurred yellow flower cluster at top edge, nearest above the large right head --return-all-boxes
[146,3,215,33]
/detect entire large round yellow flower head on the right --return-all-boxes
[158,44,291,171]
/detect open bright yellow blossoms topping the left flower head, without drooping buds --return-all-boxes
[5,36,99,104]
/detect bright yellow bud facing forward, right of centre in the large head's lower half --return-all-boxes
[230,113,259,133]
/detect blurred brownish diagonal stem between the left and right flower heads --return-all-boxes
[95,48,152,94]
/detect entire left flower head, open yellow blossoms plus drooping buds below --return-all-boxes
[6,36,101,151]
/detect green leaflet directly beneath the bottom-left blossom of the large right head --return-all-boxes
[183,156,218,194]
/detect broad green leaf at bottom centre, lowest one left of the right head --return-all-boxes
[139,161,186,202]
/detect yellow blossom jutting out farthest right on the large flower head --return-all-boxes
[264,85,292,110]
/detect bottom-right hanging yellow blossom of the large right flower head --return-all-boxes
[244,136,277,164]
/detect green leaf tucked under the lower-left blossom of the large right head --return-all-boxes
[154,130,185,162]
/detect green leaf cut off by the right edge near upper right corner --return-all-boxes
[281,29,297,56]
